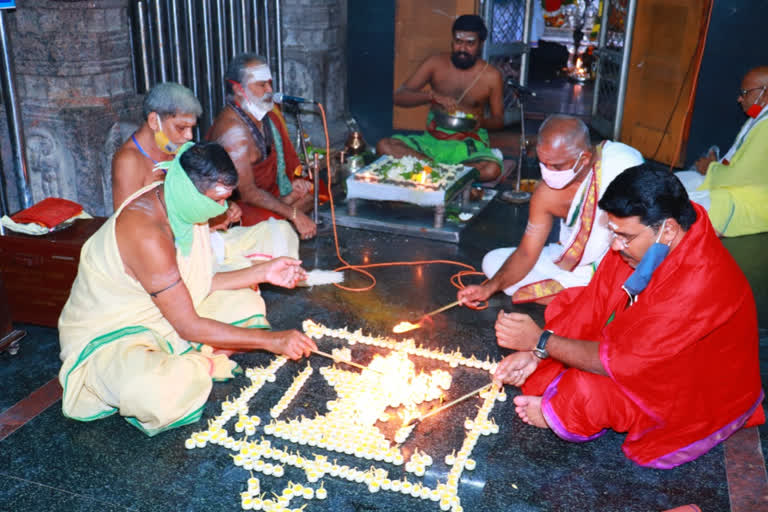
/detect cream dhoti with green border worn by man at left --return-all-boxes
[59,183,269,436]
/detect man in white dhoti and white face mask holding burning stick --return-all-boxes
[458,115,643,304]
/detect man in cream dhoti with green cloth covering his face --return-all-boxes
[59,142,316,436]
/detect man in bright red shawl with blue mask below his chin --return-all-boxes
[495,166,765,469]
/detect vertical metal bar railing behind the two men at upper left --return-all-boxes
[129,0,284,136]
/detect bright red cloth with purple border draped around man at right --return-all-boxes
[523,203,765,468]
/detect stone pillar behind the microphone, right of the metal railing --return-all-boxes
[281,0,347,149]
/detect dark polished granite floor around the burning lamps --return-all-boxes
[0,189,768,512]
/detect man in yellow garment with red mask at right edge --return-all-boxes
[676,66,768,236]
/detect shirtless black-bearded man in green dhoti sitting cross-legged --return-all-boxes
[376,14,504,181]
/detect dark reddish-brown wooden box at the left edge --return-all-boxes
[0,217,106,327]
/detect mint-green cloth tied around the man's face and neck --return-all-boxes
[156,142,227,256]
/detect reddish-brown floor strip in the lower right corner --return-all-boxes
[723,427,768,512]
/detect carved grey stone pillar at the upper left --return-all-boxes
[0,0,141,215]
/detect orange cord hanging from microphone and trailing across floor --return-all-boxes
[316,103,488,310]
